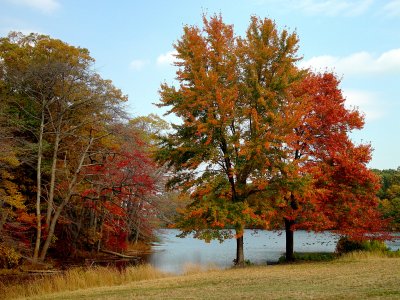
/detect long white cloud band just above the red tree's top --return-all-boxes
[299,48,400,76]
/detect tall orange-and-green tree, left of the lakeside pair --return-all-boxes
[158,16,299,265]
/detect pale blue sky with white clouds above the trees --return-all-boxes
[0,0,400,169]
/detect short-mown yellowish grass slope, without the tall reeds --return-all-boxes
[25,255,400,299]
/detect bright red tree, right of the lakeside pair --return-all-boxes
[258,72,383,260]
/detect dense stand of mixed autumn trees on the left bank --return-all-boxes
[0,33,167,268]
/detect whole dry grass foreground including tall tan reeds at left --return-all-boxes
[6,253,400,299]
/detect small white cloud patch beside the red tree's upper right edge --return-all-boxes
[343,89,385,122]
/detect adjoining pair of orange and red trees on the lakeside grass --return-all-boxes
[157,15,382,264]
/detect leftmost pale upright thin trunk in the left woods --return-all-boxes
[33,108,44,262]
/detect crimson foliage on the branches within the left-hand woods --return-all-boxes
[80,126,155,251]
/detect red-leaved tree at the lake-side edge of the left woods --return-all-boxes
[76,124,157,251]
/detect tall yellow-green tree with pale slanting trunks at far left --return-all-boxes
[0,33,125,260]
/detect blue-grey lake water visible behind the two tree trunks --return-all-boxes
[147,229,400,274]
